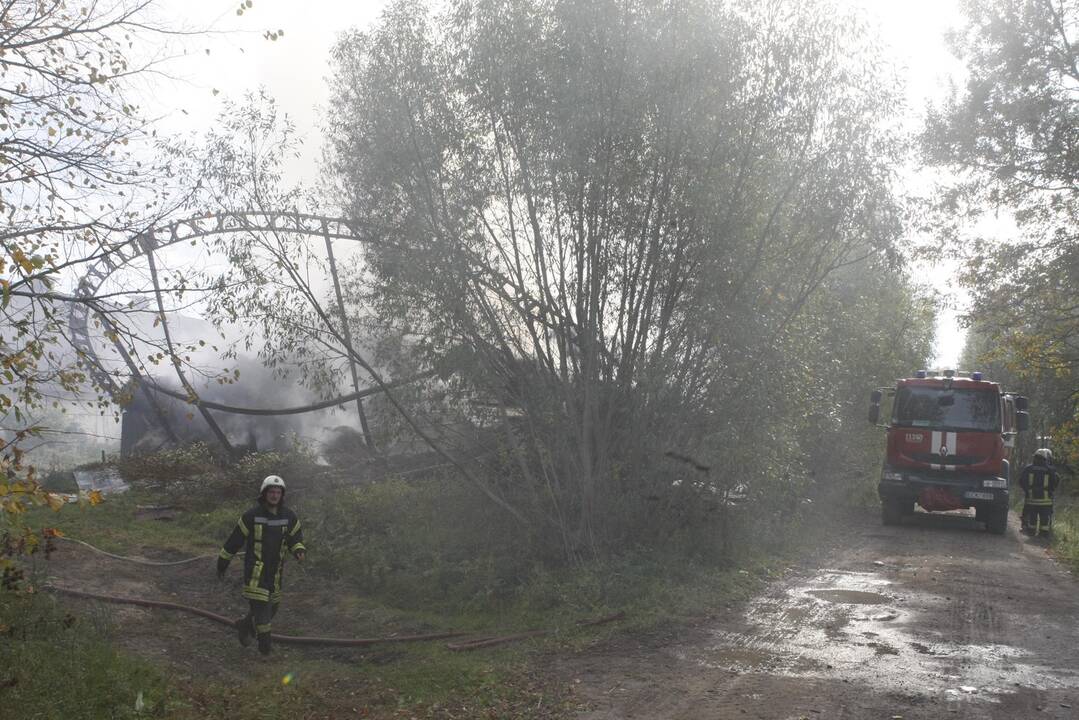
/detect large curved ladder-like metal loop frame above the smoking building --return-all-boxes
[68,210,384,434]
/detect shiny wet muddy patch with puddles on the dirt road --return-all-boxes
[677,569,1079,703]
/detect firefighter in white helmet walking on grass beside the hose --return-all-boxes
[217,475,306,655]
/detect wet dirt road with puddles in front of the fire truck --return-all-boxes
[570,514,1079,720]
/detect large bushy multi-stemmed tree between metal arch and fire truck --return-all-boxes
[312,0,925,552]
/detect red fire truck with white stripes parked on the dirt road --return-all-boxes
[869,370,1029,534]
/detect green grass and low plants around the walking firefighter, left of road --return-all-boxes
[0,446,820,720]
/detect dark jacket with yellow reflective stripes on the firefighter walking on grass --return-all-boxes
[218,502,306,602]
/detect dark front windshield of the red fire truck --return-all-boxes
[892,386,1000,433]
